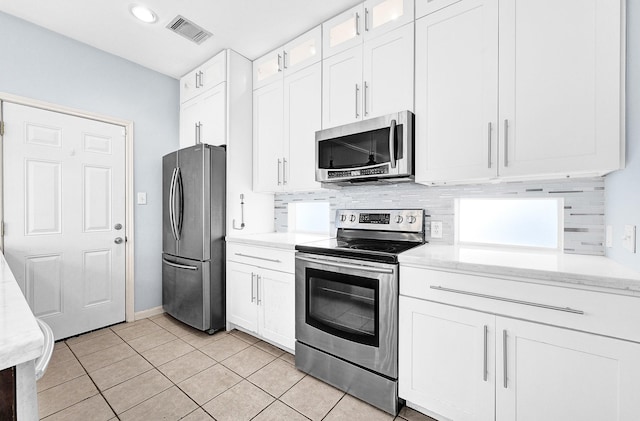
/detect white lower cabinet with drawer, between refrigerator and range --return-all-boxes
[226,241,295,351]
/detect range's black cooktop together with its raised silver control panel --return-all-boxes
[296,209,425,263]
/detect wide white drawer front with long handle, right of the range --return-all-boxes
[400,265,640,342]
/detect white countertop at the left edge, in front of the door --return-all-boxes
[0,253,44,370]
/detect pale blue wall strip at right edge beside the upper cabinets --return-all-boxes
[605,0,640,270]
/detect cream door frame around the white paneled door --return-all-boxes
[0,91,135,322]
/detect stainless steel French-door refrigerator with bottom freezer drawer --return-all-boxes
[162,144,226,333]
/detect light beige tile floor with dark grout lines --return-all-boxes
[38,314,433,421]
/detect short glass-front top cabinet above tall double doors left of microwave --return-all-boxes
[253,26,322,89]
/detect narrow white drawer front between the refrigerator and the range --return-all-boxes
[227,243,295,273]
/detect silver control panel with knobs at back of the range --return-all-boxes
[336,209,424,232]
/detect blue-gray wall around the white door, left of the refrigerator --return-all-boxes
[0,12,180,311]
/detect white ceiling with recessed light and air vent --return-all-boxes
[0,0,361,78]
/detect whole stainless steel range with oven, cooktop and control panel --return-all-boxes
[296,209,425,415]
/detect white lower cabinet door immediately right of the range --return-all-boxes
[398,297,495,421]
